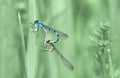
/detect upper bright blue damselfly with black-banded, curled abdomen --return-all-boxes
[33,20,68,44]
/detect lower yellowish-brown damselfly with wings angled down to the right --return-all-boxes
[44,40,74,70]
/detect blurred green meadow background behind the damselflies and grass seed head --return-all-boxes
[0,0,120,78]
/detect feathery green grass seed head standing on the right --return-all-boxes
[92,23,114,78]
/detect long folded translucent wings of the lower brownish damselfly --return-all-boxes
[54,46,74,70]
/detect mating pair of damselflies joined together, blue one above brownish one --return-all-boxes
[30,20,74,70]
